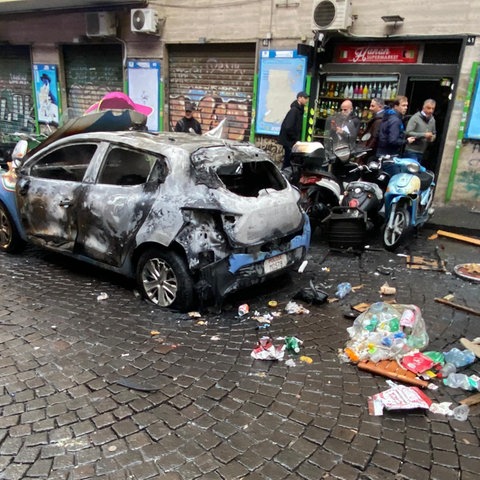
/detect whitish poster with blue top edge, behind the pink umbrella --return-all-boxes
[127,60,160,132]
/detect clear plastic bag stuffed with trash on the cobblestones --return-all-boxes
[341,302,429,362]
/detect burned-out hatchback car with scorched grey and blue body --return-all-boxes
[0,112,310,311]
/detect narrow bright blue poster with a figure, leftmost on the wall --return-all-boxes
[33,64,60,126]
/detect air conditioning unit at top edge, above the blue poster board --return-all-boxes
[312,0,352,30]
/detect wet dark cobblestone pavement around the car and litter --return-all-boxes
[0,230,480,480]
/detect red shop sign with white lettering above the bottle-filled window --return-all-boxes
[335,45,418,63]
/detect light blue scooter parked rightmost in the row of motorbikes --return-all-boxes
[382,157,435,251]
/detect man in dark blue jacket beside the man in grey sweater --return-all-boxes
[377,95,415,157]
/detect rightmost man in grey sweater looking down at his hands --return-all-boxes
[405,98,437,163]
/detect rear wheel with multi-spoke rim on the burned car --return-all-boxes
[137,248,195,312]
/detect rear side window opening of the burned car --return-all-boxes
[98,147,166,186]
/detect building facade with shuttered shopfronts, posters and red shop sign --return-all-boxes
[0,0,480,207]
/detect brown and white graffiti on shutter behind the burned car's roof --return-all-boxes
[169,90,251,141]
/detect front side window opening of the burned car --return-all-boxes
[30,144,97,182]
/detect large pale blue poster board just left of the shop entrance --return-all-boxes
[255,50,307,135]
